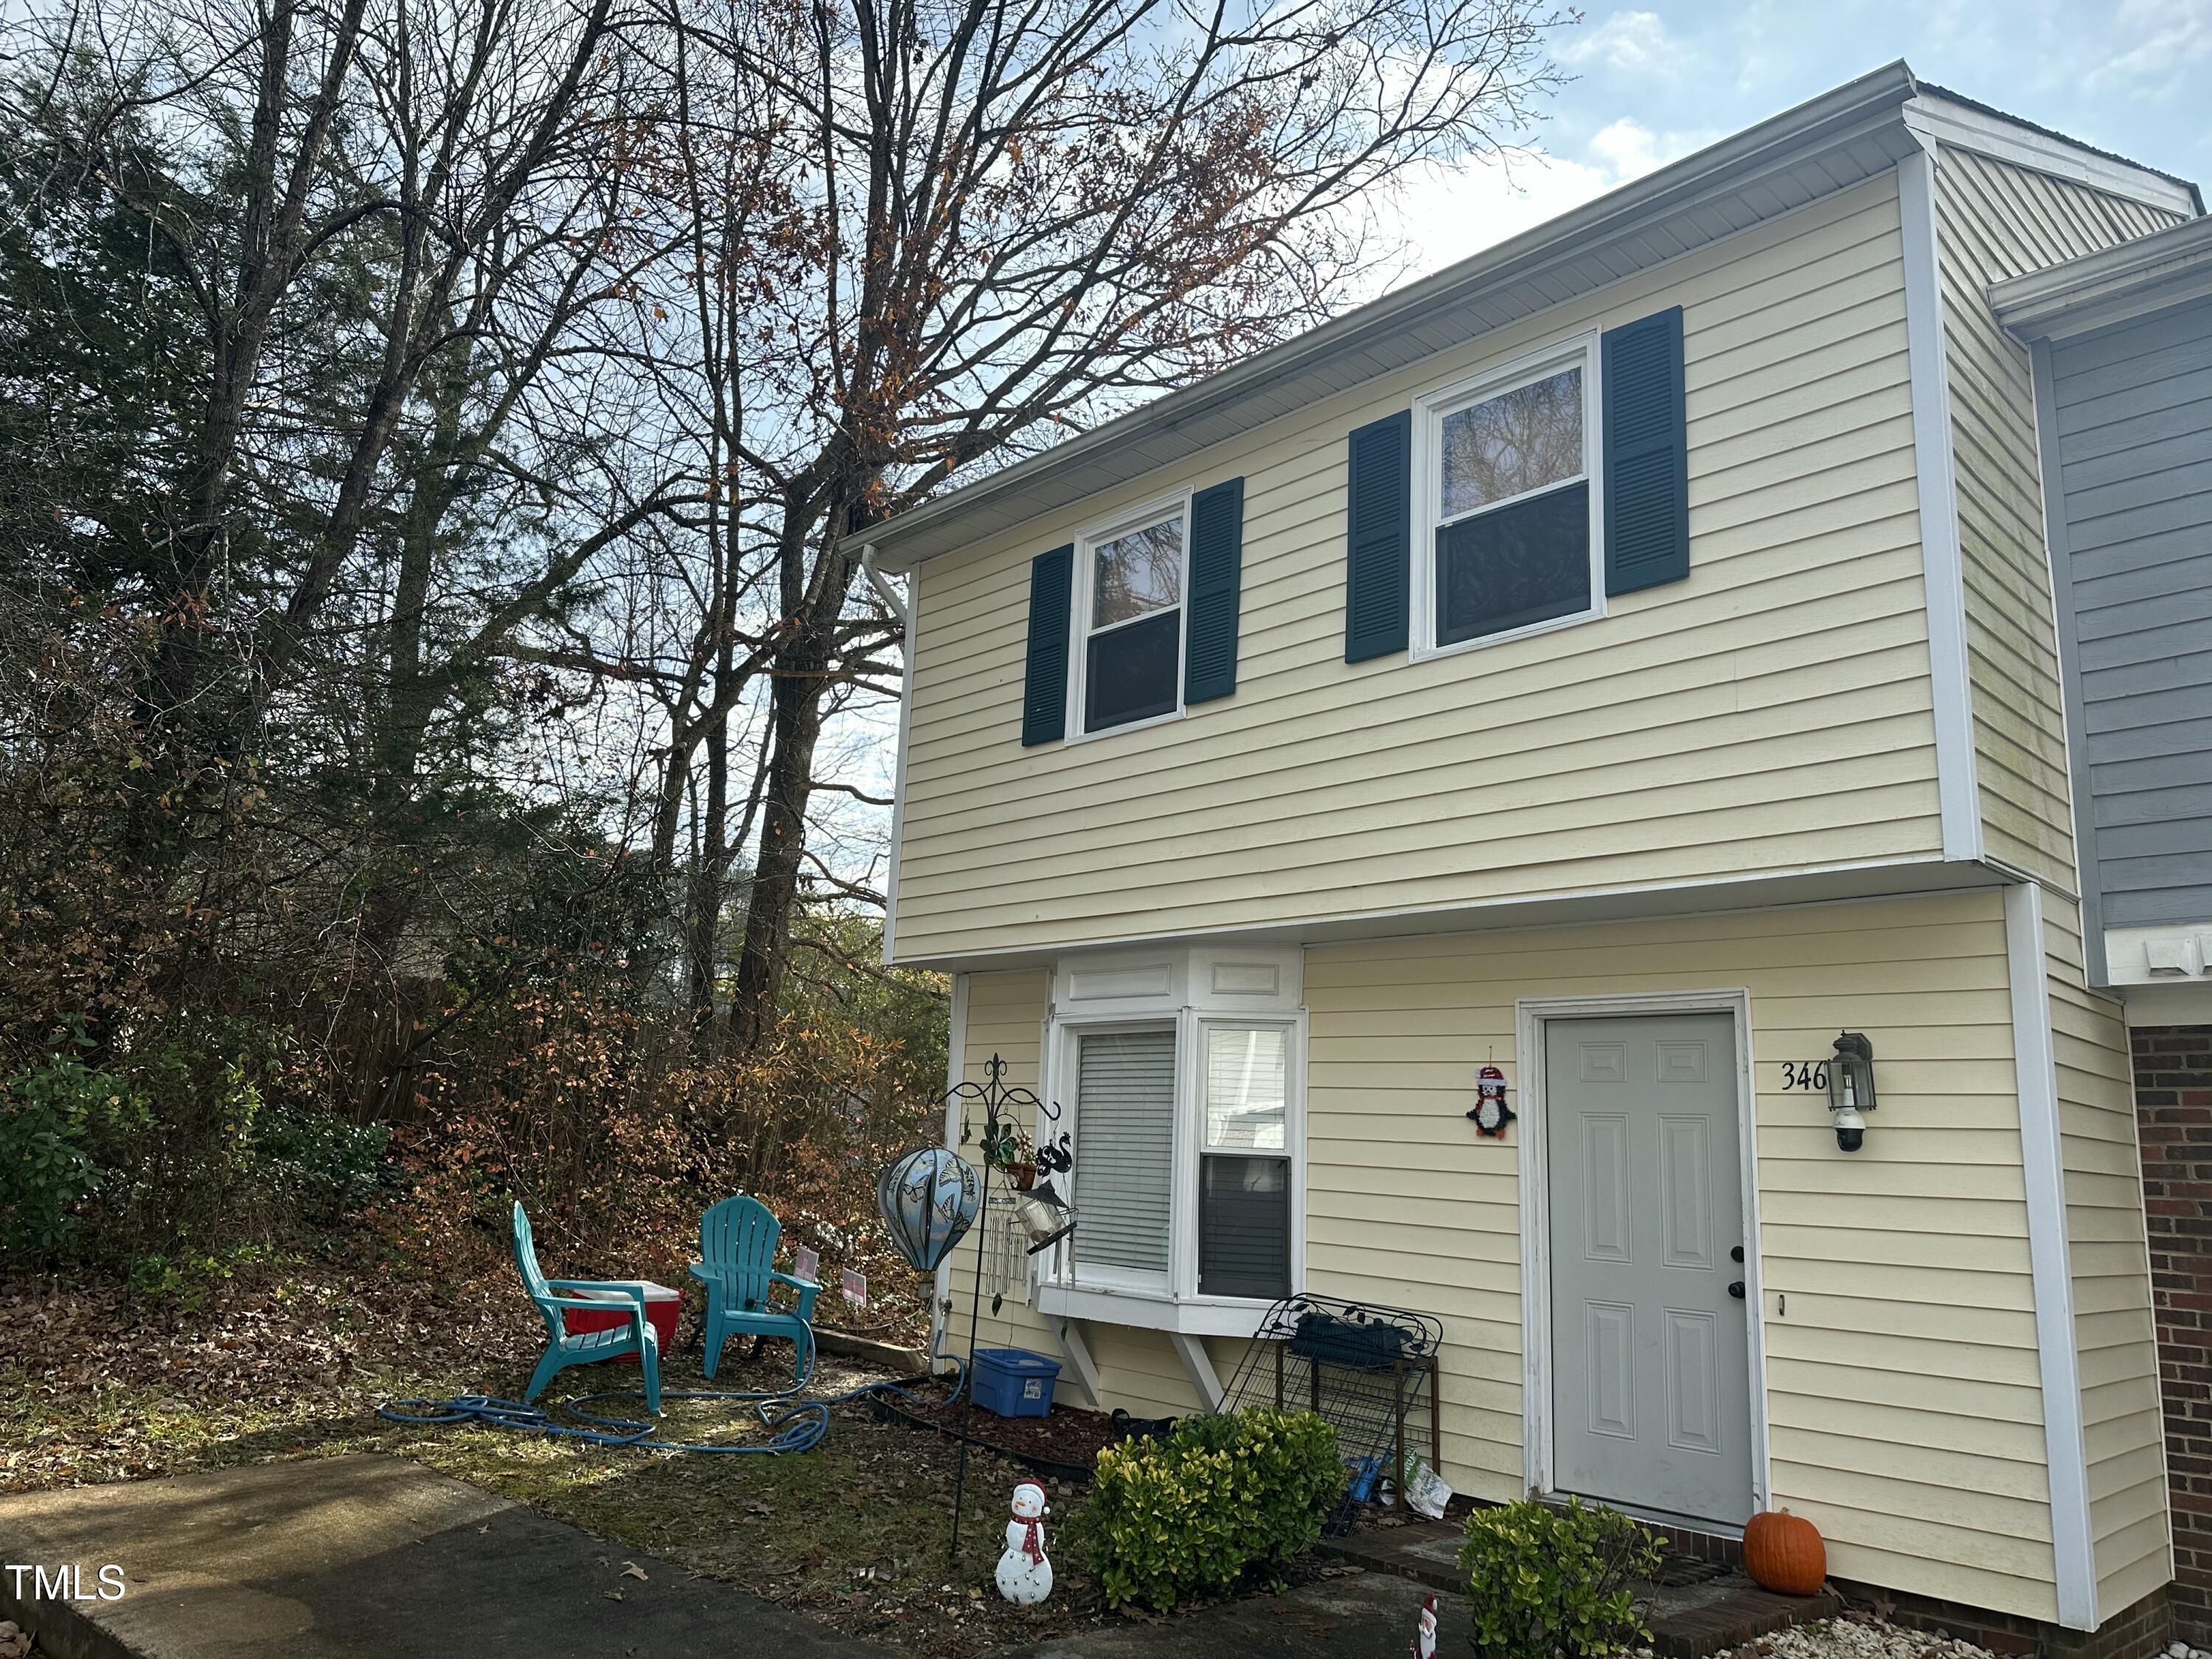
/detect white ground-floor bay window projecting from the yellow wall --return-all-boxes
[1042,951,1305,1332]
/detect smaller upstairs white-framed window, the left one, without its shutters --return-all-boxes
[1068,495,1190,737]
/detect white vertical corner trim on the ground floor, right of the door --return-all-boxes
[2004,883,2097,1630]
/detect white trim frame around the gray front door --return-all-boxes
[1513,989,1774,1524]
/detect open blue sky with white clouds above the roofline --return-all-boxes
[1402,0,2212,270]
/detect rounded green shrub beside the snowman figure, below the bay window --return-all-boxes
[1084,1407,1345,1610]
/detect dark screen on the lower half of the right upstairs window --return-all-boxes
[1436,482,1590,646]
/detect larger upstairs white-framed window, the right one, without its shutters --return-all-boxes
[1409,334,1606,659]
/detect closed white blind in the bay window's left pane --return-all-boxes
[1075,1031,1175,1276]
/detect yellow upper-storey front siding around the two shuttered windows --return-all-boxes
[896,177,1940,960]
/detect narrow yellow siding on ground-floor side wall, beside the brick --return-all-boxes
[2044,896,2172,1617]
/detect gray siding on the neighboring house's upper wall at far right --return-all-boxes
[2048,301,2212,927]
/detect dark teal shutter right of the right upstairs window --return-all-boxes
[1604,305,1690,593]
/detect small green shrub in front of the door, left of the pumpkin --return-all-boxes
[1460,1498,1666,1659]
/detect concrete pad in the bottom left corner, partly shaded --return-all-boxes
[0,1455,885,1659]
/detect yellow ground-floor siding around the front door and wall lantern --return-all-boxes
[1305,891,2057,1619]
